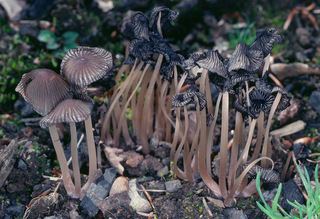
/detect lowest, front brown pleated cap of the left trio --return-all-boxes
[40,99,92,128]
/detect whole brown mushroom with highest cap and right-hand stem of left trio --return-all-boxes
[61,47,113,184]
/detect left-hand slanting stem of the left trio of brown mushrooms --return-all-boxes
[49,125,77,198]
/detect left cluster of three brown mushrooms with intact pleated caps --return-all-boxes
[16,47,113,198]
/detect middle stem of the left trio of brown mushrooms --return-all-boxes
[70,122,81,197]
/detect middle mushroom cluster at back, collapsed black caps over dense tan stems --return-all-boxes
[101,7,184,154]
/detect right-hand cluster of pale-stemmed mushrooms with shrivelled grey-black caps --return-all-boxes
[171,28,290,205]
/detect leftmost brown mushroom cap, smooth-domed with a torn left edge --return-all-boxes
[15,69,70,116]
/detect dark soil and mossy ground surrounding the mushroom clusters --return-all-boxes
[0,0,320,218]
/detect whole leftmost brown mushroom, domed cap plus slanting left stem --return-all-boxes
[16,69,75,197]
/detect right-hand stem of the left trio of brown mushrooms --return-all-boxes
[84,116,97,181]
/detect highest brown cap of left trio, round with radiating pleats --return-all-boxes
[61,47,113,87]
